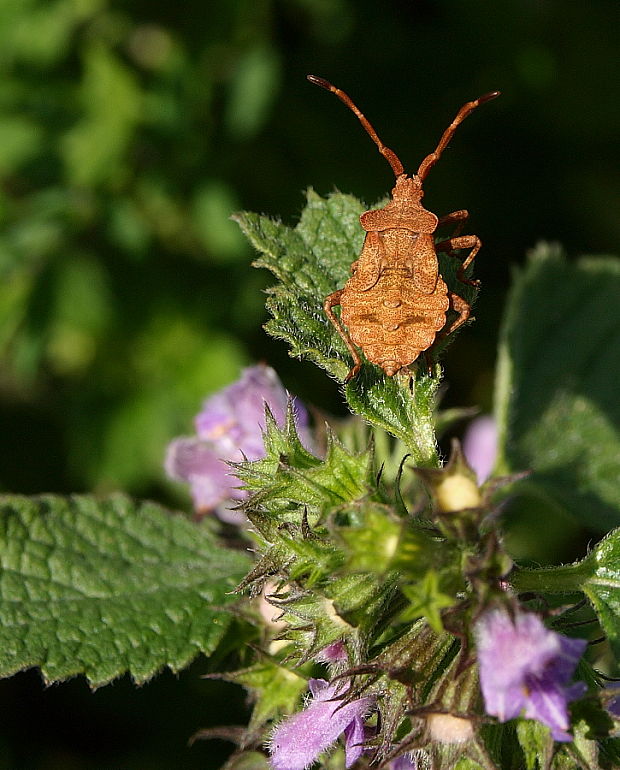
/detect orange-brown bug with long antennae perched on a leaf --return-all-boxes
[308,75,499,382]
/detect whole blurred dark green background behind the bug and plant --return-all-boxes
[0,0,620,770]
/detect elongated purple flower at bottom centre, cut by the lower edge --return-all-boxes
[269,679,373,770]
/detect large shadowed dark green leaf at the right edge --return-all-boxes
[496,244,620,530]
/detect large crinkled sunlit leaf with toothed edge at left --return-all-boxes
[0,495,249,686]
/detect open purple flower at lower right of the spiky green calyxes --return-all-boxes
[475,609,587,741]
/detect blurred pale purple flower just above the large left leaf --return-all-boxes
[165,365,311,523]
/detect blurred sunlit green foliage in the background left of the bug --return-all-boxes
[0,0,281,493]
